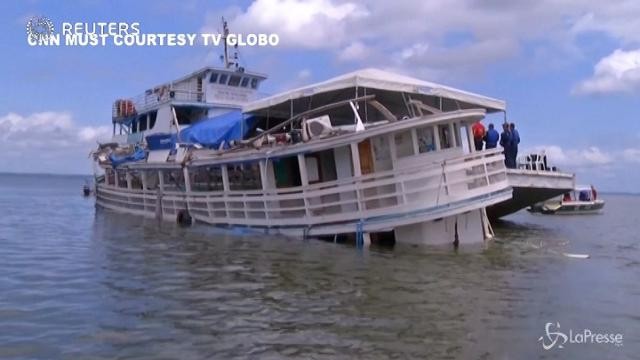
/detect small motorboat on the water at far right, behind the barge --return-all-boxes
[527,185,604,215]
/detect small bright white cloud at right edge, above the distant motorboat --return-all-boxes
[574,49,640,94]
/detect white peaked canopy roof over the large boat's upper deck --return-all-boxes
[243,68,506,112]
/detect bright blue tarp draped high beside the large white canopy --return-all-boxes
[179,110,255,148]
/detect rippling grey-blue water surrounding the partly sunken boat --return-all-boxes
[0,175,640,359]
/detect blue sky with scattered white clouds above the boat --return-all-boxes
[0,0,640,192]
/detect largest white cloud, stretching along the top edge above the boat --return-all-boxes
[204,0,640,77]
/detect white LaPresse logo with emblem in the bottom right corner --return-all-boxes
[538,322,624,350]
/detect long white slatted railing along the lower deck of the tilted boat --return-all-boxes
[98,150,508,227]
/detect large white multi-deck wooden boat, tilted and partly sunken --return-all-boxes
[94,26,511,244]
